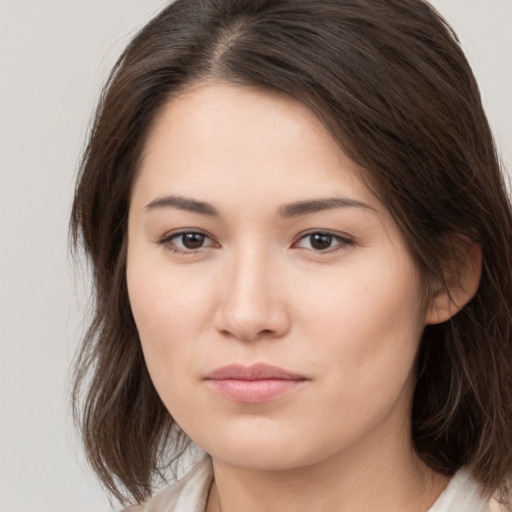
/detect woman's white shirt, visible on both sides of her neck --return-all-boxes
[124,457,499,512]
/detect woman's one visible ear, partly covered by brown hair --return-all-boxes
[425,244,482,325]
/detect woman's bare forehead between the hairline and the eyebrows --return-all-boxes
[134,83,375,212]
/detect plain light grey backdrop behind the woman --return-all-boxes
[0,0,512,512]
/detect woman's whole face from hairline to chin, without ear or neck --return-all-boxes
[127,83,428,469]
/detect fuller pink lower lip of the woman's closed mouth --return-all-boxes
[208,379,303,404]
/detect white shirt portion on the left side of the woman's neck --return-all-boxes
[122,457,213,512]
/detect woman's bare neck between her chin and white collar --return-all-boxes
[207,412,448,512]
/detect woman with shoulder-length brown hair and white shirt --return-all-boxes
[72,0,512,512]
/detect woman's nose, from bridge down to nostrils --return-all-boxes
[214,250,290,341]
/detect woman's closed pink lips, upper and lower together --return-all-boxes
[205,363,307,404]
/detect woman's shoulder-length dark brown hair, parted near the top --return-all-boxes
[71,0,512,502]
